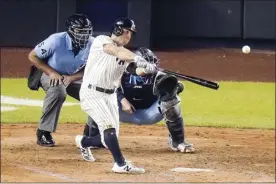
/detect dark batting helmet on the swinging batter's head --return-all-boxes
[112,18,136,36]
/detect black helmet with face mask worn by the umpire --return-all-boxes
[66,14,93,49]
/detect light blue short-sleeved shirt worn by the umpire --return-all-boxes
[35,32,94,75]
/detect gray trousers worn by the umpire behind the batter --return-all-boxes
[38,73,92,132]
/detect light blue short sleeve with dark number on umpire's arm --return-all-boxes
[34,36,55,59]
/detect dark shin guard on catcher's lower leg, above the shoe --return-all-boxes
[166,117,184,146]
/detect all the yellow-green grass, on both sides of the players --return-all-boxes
[1,79,275,129]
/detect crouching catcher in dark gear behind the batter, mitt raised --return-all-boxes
[80,48,195,153]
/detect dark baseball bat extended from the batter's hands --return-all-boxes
[160,69,219,90]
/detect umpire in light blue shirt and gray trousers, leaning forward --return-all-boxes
[28,14,94,147]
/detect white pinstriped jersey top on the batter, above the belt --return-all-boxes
[82,35,127,89]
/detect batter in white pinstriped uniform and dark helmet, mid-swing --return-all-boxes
[76,18,156,173]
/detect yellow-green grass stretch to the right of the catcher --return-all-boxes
[181,82,275,128]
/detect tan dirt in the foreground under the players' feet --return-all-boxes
[1,124,275,182]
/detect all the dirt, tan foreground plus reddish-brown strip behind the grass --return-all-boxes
[1,48,275,182]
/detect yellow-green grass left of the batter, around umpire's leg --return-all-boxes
[1,79,87,123]
